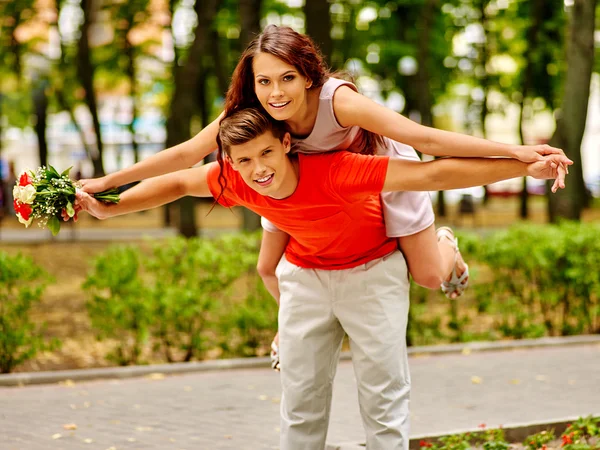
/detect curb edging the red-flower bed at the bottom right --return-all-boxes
[326,412,600,450]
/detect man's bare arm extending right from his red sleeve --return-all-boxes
[382,155,566,192]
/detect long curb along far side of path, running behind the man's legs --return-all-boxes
[0,335,600,386]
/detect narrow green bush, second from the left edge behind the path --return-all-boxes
[83,246,152,365]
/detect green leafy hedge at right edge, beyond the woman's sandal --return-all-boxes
[476,223,600,338]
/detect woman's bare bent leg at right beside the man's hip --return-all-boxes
[398,225,467,298]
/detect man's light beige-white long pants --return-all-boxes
[277,251,410,450]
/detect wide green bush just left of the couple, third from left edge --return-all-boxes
[145,235,256,361]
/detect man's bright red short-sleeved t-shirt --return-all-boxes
[207,151,396,270]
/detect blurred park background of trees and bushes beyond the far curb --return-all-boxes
[0,0,600,372]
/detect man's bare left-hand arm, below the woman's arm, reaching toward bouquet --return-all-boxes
[76,163,217,219]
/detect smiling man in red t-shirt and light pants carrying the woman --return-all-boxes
[77,108,564,450]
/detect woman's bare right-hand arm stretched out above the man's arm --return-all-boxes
[333,86,568,163]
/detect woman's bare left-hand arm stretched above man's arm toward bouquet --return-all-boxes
[81,114,222,193]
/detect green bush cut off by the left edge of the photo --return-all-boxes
[0,252,60,373]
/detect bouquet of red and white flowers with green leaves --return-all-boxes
[13,166,119,236]
